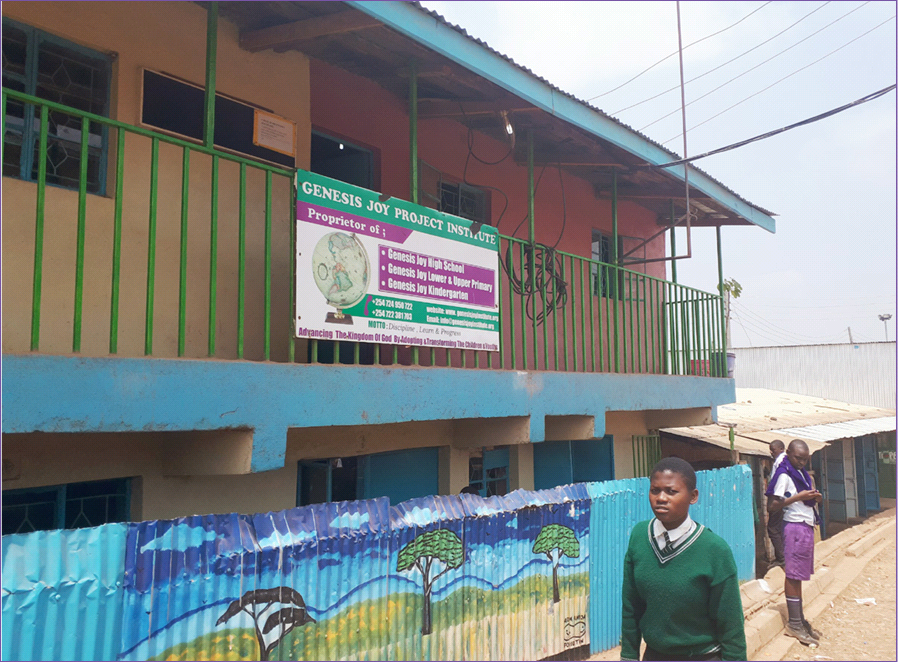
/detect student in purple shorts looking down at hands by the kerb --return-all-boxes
[766,439,822,646]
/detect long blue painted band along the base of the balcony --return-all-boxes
[3,355,735,471]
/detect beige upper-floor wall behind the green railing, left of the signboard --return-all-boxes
[2,2,311,360]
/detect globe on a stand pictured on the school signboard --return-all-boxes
[312,232,369,324]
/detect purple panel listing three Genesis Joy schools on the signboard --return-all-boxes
[378,245,496,308]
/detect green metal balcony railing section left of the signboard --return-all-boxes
[2,89,294,360]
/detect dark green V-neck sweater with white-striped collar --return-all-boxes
[622,520,747,660]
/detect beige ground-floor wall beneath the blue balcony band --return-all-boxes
[3,419,534,520]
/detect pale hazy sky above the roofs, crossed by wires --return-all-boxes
[422,0,897,347]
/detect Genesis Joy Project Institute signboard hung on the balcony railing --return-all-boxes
[294,170,500,351]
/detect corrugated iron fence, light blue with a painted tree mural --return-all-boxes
[2,466,753,660]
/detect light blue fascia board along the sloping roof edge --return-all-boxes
[347,0,775,234]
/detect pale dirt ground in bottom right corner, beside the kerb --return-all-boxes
[782,540,897,661]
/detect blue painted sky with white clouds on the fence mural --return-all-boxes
[123,486,590,659]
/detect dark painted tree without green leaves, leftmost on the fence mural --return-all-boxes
[216,586,316,660]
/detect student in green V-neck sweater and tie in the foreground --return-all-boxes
[622,457,747,660]
